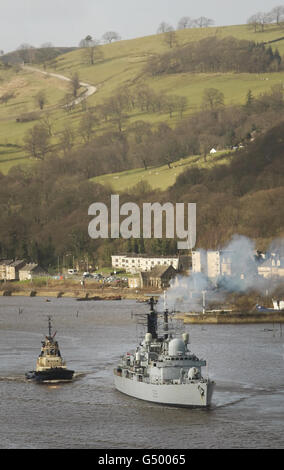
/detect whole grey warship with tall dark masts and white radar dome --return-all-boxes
[114,298,215,408]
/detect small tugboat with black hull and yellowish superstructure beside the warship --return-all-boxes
[25,317,74,382]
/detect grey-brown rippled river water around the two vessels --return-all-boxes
[0,297,284,449]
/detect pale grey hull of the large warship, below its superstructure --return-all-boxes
[114,374,214,408]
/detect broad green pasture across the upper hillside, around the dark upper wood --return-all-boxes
[0,21,284,173]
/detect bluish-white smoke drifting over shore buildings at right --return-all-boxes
[158,235,284,312]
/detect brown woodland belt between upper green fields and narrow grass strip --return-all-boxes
[23,84,284,178]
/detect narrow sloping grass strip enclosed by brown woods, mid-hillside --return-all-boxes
[91,151,230,193]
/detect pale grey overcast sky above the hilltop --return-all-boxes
[0,0,284,52]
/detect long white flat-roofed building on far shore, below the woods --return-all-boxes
[111,254,182,274]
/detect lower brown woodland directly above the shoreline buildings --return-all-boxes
[0,117,284,268]
